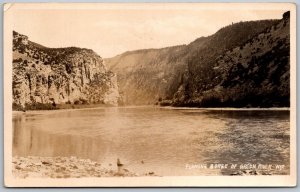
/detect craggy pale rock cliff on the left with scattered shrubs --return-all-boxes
[12,32,119,107]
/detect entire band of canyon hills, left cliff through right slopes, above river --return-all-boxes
[12,12,290,109]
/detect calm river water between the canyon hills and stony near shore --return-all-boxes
[13,107,290,176]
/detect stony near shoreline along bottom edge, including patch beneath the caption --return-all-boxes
[12,156,289,179]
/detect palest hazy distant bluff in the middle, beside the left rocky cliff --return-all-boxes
[104,45,186,105]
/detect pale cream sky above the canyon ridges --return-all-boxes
[12,4,286,58]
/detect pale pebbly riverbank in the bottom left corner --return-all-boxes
[12,156,154,178]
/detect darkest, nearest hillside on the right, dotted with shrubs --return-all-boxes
[172,12,290,107]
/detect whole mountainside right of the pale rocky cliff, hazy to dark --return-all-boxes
[106,12,289,107]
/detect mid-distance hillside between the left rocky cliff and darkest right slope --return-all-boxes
[104,17,280,106]
